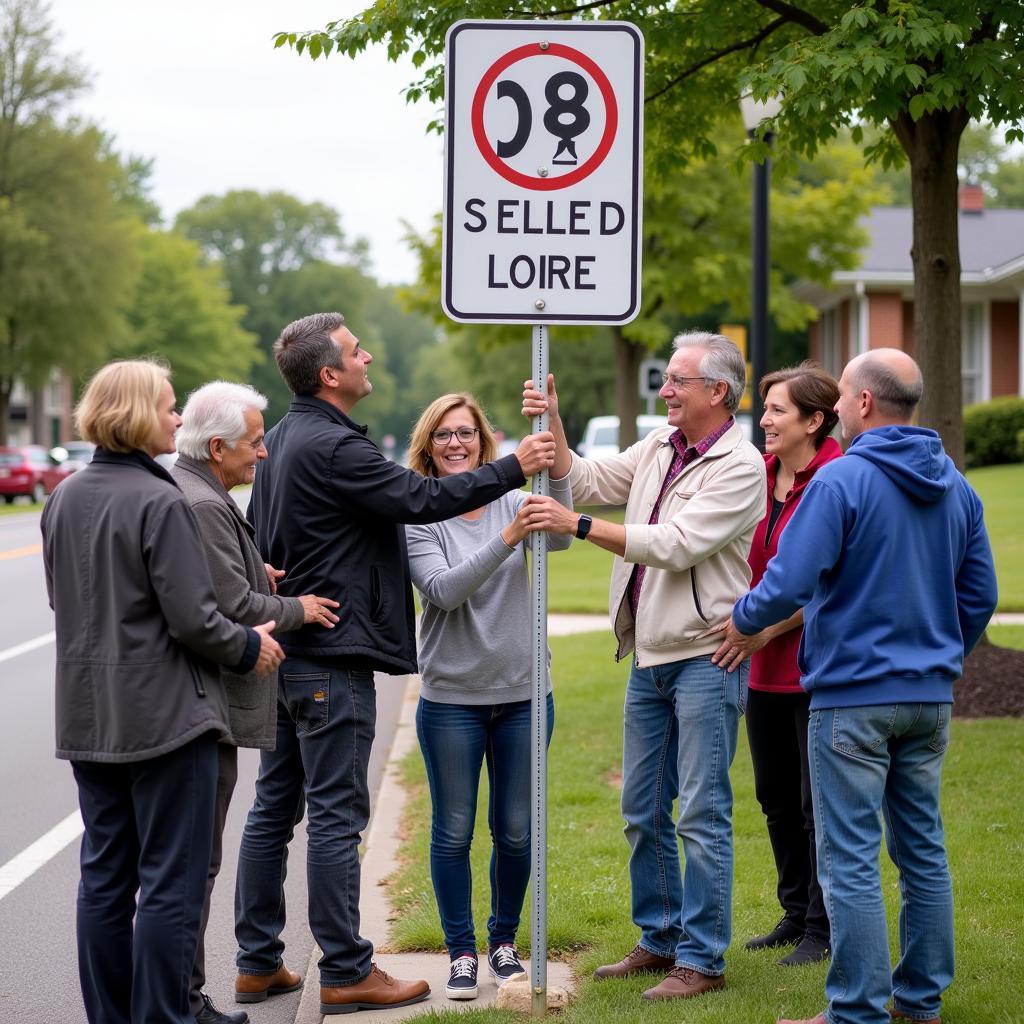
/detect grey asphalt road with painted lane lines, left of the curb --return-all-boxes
[0,512,404,1024]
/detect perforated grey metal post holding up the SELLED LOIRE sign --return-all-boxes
[529,326,549,1017]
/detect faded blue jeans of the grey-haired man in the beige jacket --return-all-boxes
[623,655,746,975]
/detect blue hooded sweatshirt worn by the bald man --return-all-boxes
[733,426,996,710]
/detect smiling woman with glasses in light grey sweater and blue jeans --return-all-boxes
[406,394,571,999]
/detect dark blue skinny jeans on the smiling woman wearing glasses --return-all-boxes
[416,693,555,957]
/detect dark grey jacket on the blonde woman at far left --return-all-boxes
[41,449,260,762]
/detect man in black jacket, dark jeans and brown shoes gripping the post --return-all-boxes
[236,313,554,1014]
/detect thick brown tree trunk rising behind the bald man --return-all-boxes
[894,110,968,469]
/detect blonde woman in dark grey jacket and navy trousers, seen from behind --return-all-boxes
[42,359,283,1024]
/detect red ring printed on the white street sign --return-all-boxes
[472,43,618,191]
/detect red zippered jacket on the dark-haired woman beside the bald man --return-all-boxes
[748,437,843,693]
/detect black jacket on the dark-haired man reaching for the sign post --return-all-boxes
[248,395,525,675]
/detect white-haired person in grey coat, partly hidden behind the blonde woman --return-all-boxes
[171,381,338,1024]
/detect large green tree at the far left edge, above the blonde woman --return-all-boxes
[0,0,135,443]
